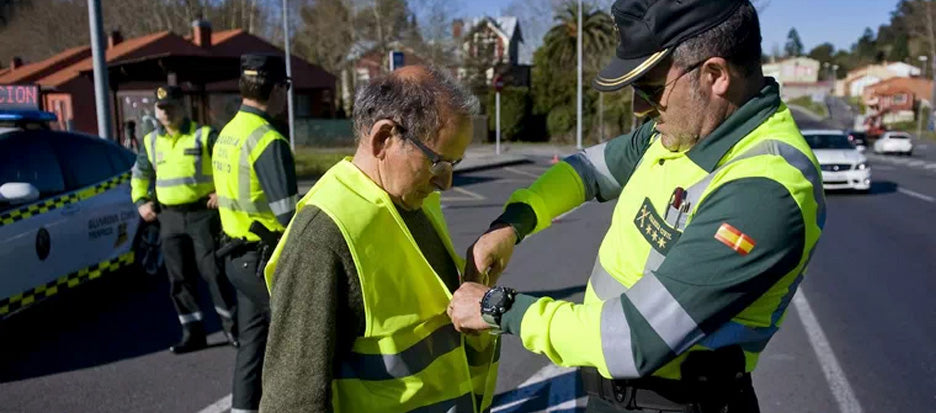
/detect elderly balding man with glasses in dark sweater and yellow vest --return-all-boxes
[261,66,499,412]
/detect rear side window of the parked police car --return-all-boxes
[50,132,123,191]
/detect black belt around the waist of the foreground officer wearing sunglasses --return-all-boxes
[582,367,751,412]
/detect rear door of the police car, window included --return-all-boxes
[51,133,139,274]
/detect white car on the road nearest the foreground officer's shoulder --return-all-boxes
[802,130,871,191]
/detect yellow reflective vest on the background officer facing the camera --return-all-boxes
[130,121,214,205]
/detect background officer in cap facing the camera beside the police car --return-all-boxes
[130,86,238,354]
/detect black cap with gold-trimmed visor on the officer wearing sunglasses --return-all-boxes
[592,0,748,92]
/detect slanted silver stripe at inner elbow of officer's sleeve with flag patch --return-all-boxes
[625,273,704,354]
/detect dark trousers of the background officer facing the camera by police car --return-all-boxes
[159,207,236,335]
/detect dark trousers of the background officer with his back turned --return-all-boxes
[225,250,270,410]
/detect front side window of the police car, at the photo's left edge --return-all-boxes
[0,131,65,199]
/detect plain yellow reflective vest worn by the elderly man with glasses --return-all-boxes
[265,159,500,412]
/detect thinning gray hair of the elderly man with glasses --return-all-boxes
[353,67,479,143]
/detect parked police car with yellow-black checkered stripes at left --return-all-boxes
[0,99,161,319]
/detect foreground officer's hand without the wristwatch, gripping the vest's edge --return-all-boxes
[464,225,517,287]
